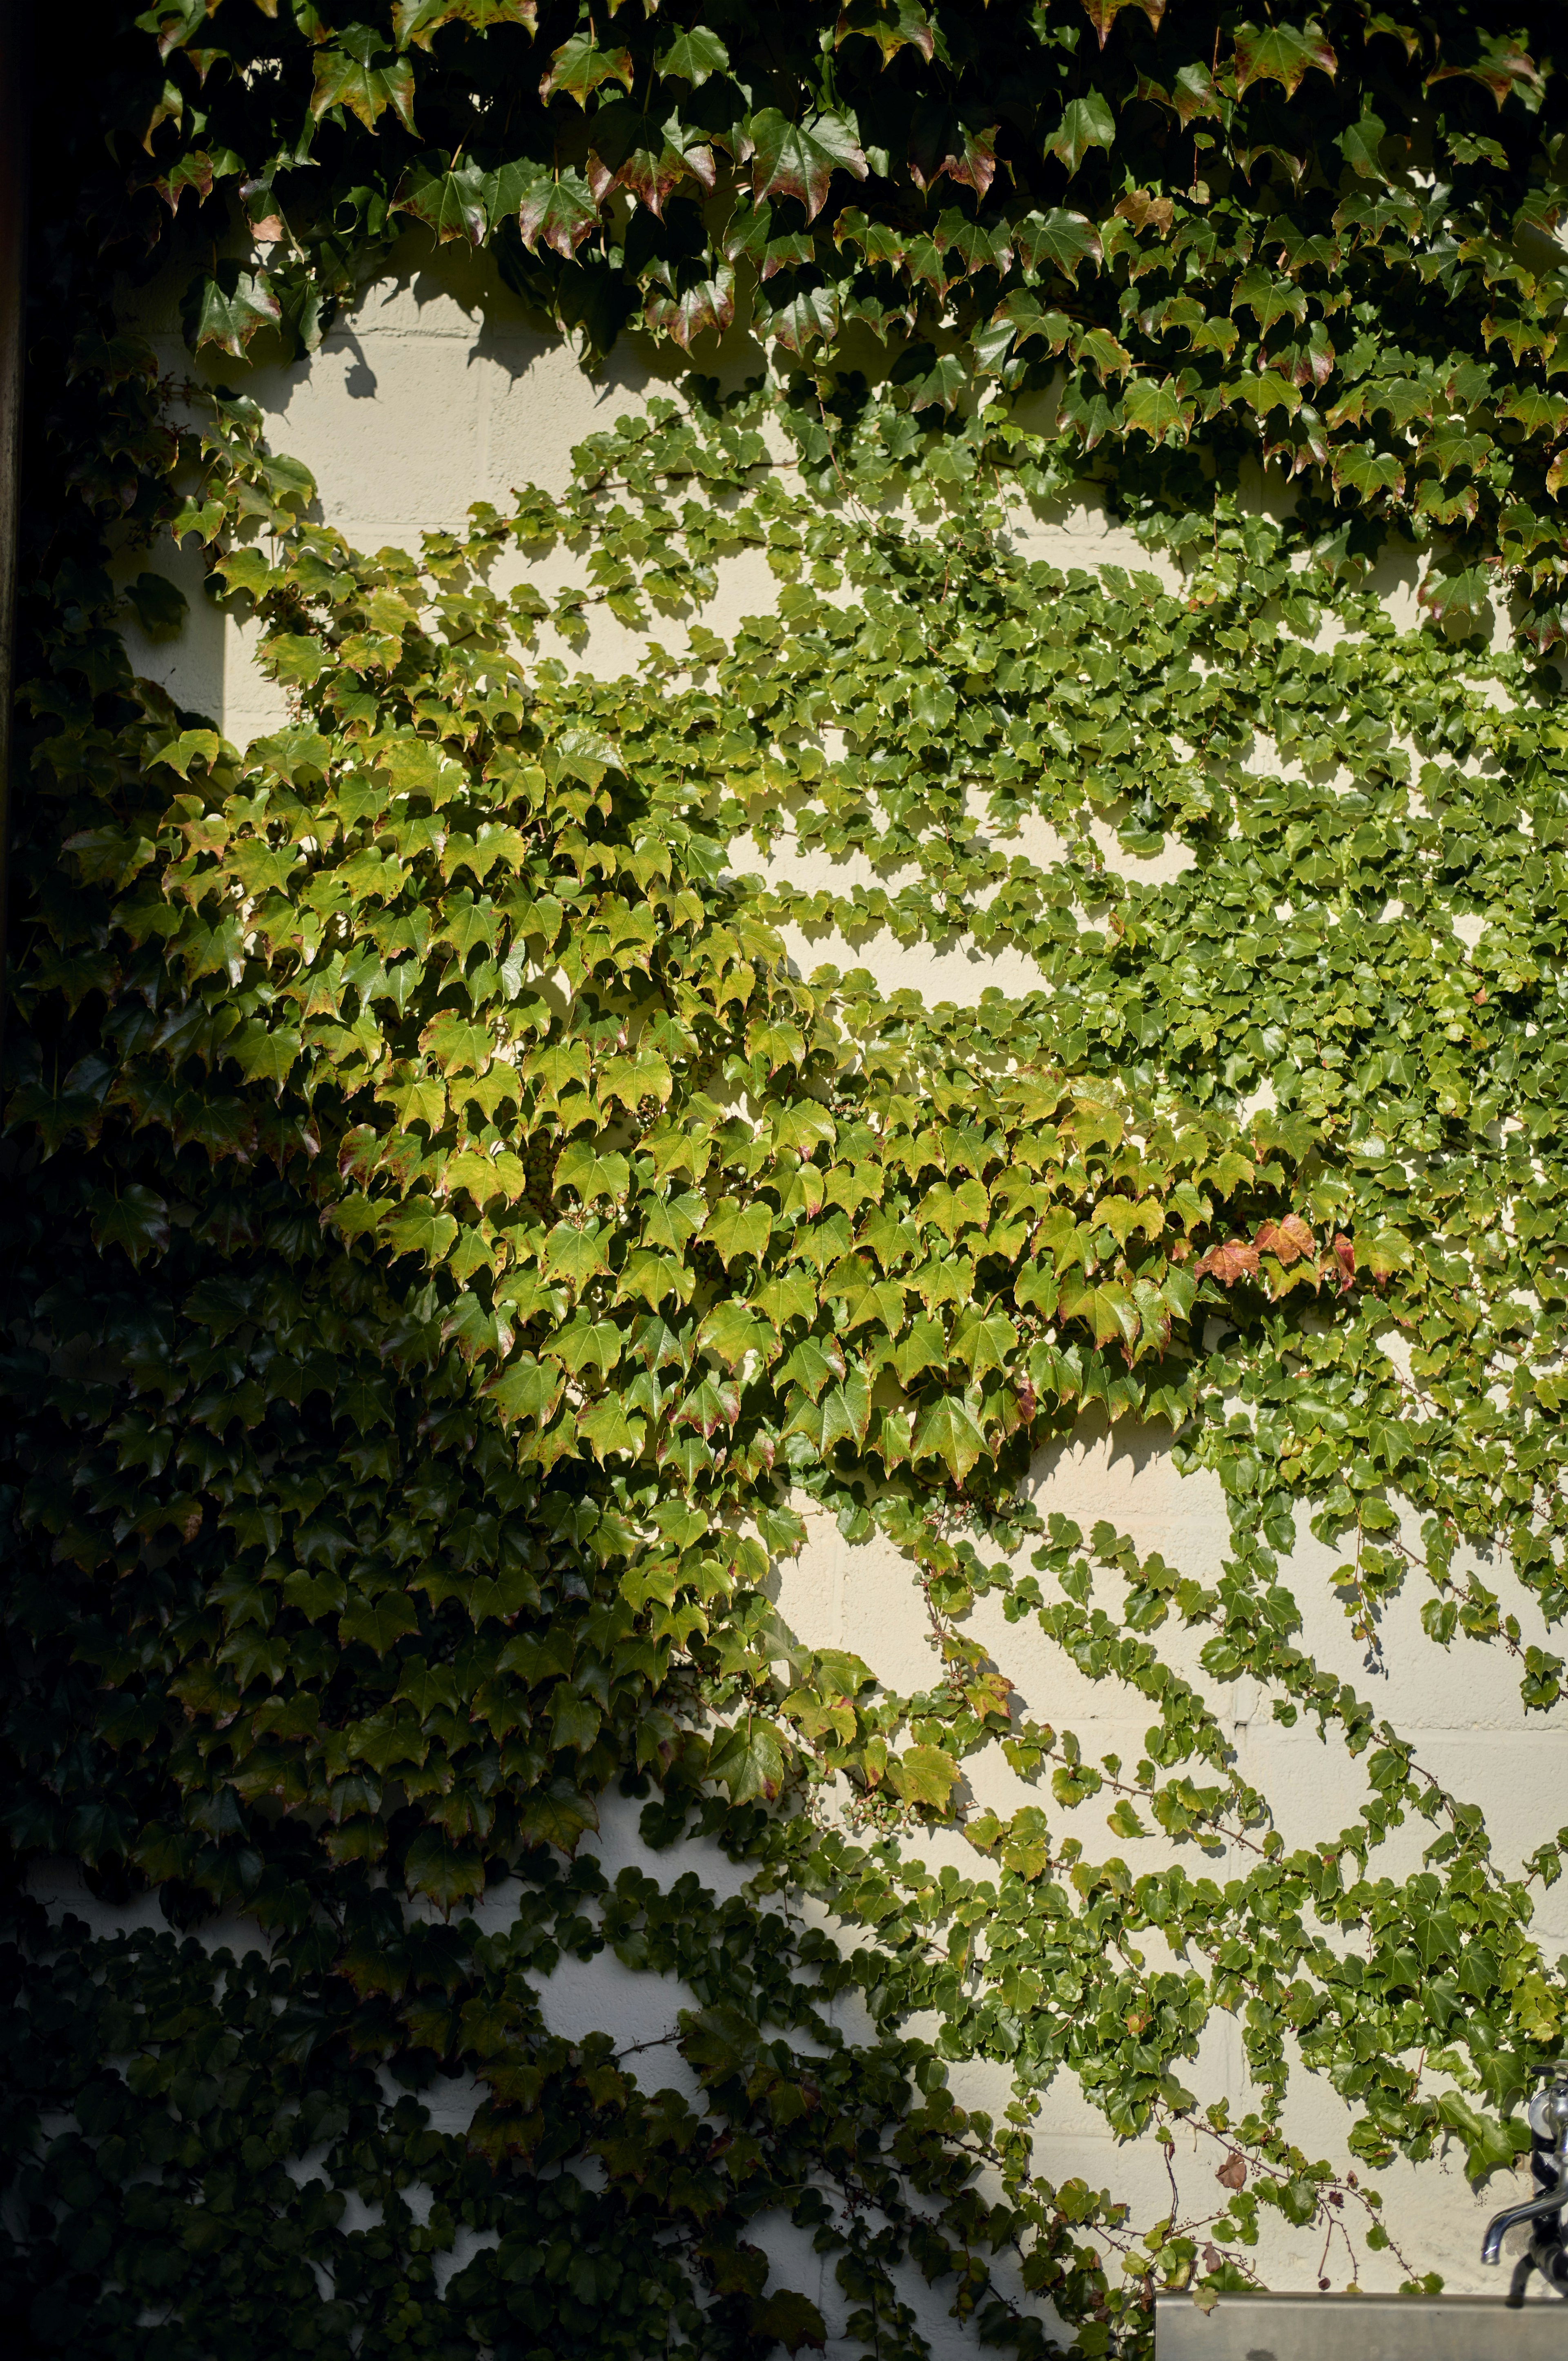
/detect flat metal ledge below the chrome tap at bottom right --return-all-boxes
[1155,2295,1568,2361]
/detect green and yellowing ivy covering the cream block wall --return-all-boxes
[5,0,1568,2361]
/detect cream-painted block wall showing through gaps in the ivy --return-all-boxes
[101,230,1568,2352]
